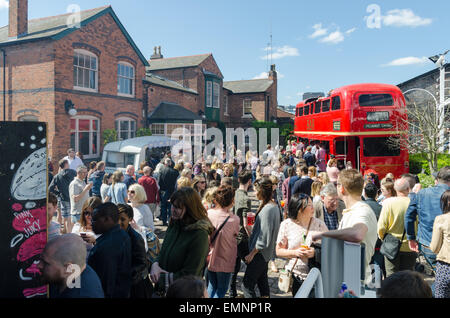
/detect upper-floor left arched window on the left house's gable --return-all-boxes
[73,50,98,92]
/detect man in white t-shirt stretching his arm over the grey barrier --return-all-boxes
[312,169,377,283]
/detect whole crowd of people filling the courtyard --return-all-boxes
[39,142,450,298]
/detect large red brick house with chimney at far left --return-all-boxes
[0,0,148,162]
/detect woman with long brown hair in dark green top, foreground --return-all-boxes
[150,188,214,292]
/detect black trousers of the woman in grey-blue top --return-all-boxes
[242,253,270,298]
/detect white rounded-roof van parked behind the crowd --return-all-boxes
[102,136,179,173]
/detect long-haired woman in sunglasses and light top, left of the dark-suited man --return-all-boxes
[72,197,102,256]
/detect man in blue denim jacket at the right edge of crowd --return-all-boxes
[405,166,450,265]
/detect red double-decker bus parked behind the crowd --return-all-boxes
[294,84,409,179]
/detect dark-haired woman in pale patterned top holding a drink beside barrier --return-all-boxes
[276,193,328,296]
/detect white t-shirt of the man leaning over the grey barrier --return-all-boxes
[339,201,378,283]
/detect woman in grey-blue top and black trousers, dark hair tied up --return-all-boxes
[243,178,281,298]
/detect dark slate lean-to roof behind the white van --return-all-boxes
[148,102,202,123]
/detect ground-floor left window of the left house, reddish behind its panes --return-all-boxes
[70,116,100,159]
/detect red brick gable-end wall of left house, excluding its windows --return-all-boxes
[50,14,145,161]
